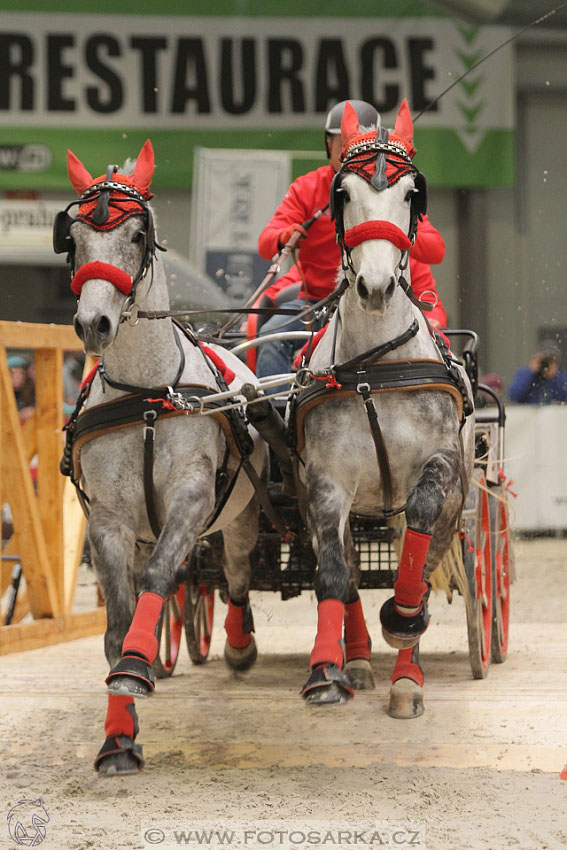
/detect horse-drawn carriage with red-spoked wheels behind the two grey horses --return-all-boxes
[154,324,514,679]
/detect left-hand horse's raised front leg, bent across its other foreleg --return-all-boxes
[106,464,214,696]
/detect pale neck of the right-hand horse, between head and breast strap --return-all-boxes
[331,274,438,363]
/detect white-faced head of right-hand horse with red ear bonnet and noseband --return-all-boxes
[331,99,425,315]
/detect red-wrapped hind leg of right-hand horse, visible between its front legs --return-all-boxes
[345,523,376,691]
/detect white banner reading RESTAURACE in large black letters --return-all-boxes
[0,14,512,128]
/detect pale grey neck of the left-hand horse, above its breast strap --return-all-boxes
[104,256,189,387]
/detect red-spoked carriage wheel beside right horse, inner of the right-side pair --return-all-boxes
[463,469,492,679]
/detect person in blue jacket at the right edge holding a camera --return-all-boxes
[508,340,567,404]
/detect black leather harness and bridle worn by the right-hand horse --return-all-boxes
[290,122,474,517]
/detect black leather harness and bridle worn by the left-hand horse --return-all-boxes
[53,165,288,538]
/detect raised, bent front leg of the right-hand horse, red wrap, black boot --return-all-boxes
[380,448,460,649]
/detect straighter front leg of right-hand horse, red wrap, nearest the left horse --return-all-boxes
[301,470,354,705]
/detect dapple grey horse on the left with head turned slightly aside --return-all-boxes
[63,140,267,774]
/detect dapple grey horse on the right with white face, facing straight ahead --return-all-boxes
[298,101,474,717]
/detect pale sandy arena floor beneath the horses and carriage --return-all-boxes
[0,539,567,850]
